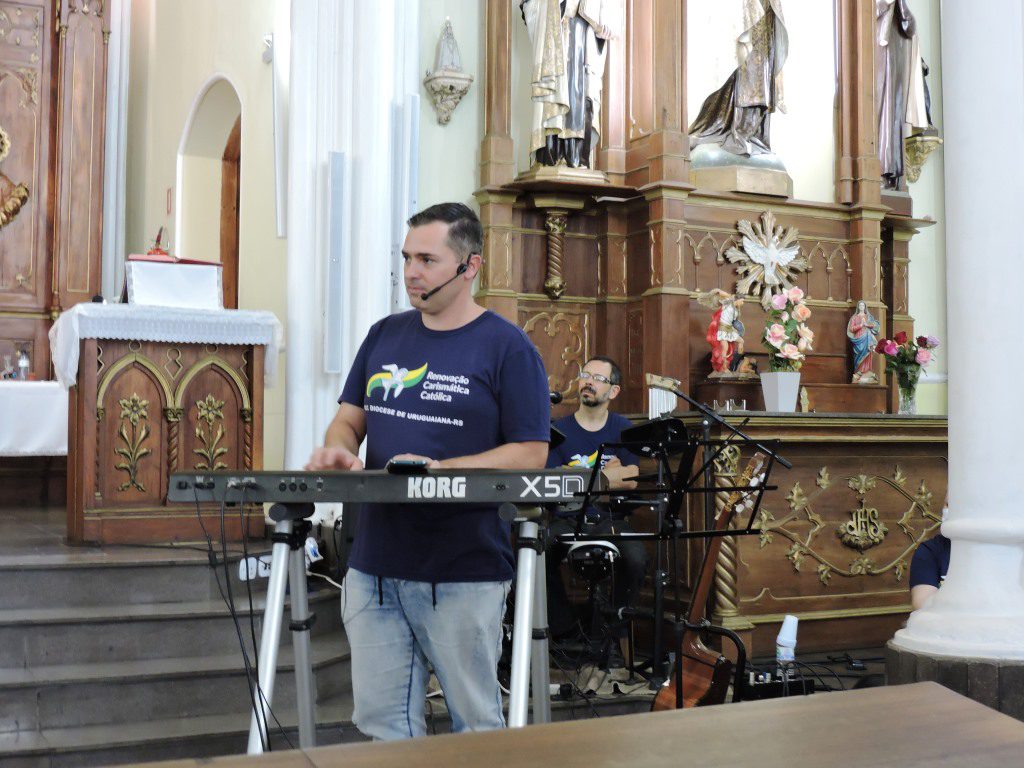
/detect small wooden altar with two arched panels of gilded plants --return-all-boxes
[68,339,264,545]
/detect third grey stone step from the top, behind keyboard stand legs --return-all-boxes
[0,633,351,733]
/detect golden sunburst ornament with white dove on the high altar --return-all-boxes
[725,211,809,309]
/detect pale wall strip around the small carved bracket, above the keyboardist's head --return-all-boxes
[418,0,484,209]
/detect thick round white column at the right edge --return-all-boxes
[893,0,1024,659]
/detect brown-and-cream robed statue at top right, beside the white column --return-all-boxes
[874,0,935,189]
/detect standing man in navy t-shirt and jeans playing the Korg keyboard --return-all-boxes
[307,203,550,739]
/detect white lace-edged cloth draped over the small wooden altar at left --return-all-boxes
[50,303,283,387]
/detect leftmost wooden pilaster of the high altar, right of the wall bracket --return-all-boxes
[480,0,515,187]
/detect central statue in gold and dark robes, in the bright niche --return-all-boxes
[689,0,790,158]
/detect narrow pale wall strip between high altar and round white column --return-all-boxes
[909,0,948,414]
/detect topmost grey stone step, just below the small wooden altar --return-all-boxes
[0,543,270,610]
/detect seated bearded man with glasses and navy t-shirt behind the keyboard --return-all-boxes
[547,356,647,663]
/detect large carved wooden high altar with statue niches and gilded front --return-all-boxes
[475,0,946,651]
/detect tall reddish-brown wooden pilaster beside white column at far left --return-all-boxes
[53,0,110,308]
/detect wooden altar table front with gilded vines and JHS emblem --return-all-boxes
[682,413,947,654]
